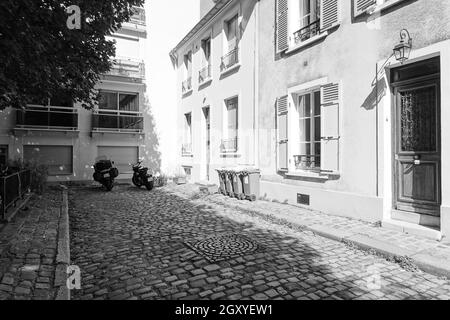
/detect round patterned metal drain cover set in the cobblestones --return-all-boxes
[185,233,259,262]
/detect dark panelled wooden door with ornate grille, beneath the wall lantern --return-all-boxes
[394,79,441,216]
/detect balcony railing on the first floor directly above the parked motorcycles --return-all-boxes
[92,110,144,133]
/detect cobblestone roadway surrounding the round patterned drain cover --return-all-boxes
[69,186,450,300]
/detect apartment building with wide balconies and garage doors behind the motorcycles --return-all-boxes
[0,7,150,181]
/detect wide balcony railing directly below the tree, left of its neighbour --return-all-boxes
[16,105,78,131]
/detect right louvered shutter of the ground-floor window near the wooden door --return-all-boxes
[321,83,341,173]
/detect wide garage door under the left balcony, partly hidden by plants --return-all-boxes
[23,146,73,176]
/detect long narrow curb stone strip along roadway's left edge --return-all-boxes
[55,186,70,300]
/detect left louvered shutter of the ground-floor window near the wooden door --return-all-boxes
[277,96,289,171]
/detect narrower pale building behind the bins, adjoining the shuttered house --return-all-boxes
[170,0,257,182]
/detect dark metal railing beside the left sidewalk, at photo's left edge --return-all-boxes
[0,170,31,220]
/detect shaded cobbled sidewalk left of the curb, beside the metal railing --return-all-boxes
[0,190,61,300]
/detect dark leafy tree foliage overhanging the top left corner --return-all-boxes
[0,0,144,109]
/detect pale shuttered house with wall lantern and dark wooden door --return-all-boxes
[258,0,450,238]
